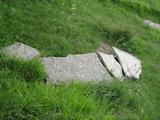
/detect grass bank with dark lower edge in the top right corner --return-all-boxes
[112,0,160,22]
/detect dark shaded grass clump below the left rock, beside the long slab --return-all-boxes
[0,55,45,82]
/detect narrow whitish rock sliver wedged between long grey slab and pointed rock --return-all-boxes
[98,52,123,79]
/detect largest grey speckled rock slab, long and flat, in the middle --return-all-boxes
[42,53,112,84]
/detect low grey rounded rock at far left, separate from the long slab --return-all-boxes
[1,42,40,60]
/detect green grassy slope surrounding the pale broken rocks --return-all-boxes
[0,0,160,120]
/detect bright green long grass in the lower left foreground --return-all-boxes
[0,70,112,120]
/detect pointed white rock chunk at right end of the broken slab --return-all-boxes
[113,47,142,79]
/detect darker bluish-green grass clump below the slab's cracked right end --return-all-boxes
[87,81,142,117]
